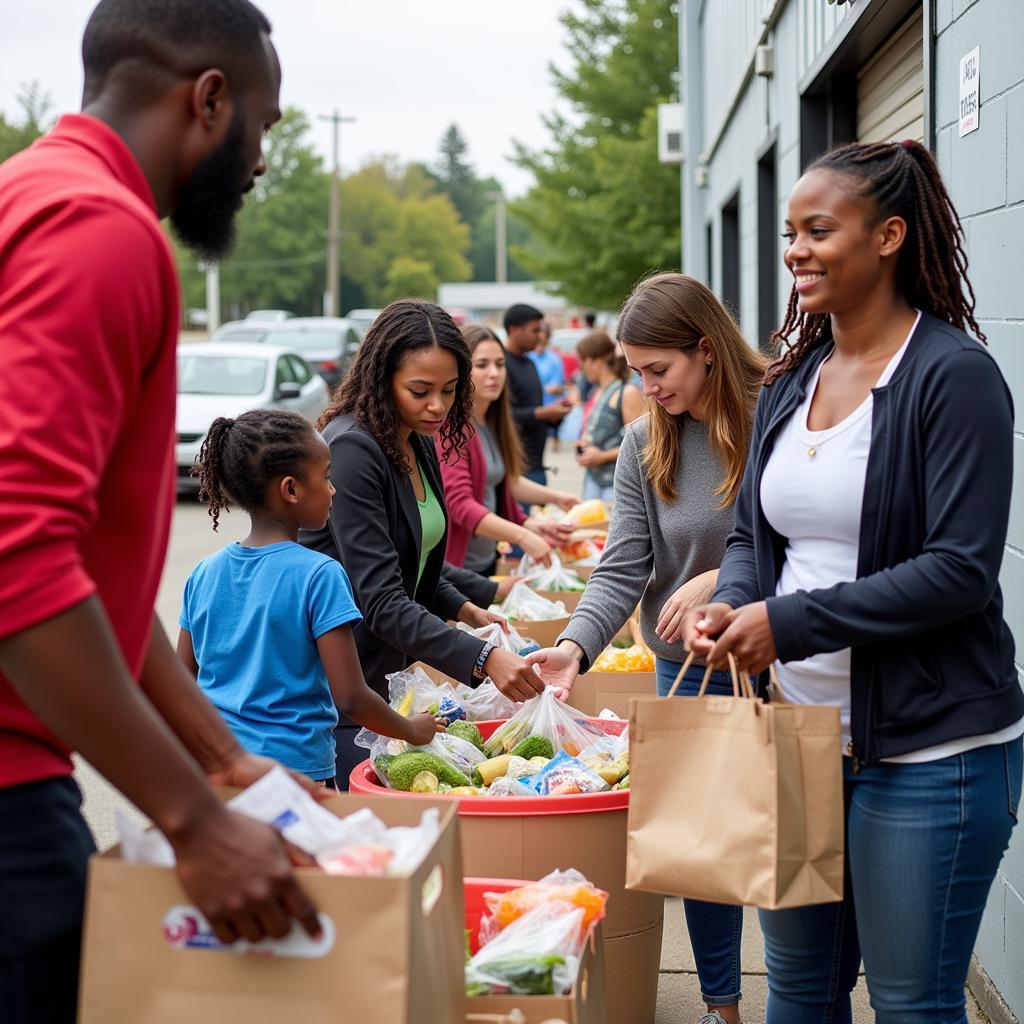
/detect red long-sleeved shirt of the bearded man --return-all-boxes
[0,115,178,787]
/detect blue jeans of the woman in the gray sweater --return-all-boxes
[654,657,743,1007]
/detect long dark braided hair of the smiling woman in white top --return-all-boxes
[765,139,985,384]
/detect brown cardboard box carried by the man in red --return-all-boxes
[79,795,465,1024]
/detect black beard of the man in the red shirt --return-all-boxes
[171,104,251,262]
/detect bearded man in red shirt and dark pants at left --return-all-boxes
[0,0,317,1024]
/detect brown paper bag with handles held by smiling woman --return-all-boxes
[626,655,844,910]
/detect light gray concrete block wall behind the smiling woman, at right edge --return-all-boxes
[935,0,1024,1020]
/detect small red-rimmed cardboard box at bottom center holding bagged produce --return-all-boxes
[466,879,613,1024]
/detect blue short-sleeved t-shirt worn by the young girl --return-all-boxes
[179,541,362,779]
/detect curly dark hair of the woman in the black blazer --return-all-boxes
[316,299,473,473]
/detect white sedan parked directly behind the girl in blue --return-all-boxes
[175,341,330,492]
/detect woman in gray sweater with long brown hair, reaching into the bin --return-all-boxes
[528,273,767,1024]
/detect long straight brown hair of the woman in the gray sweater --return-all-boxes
[618,273,768,508]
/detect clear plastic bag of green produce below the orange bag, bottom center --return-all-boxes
[466,899,586,996]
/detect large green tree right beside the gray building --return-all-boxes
[513,0,680,309]
